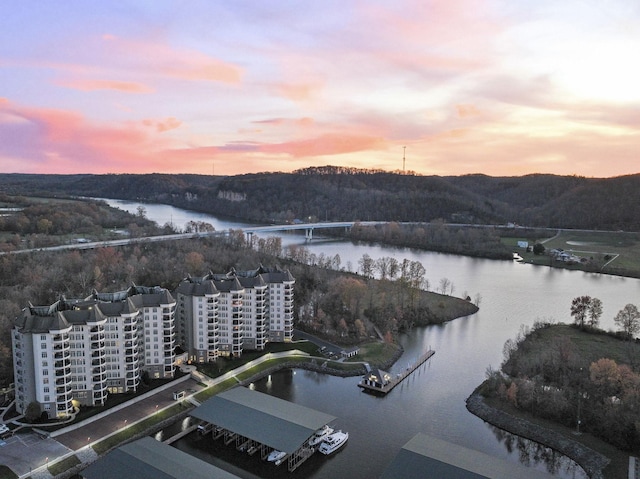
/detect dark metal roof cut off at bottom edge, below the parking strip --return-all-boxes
[81,437,238,479]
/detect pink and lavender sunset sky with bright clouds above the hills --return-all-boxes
[0,0,640,177]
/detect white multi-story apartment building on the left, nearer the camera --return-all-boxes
[12,286,175,418]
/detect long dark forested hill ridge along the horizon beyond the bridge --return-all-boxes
[0,166,640,231]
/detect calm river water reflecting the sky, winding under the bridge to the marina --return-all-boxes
[102,200,640,478]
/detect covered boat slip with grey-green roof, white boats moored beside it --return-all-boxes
[191,386,336,471]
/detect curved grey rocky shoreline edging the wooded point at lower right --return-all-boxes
[466,392,610,479]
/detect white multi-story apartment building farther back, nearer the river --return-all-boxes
[175,266,295,362]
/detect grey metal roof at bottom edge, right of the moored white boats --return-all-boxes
[380,434,553,479]
